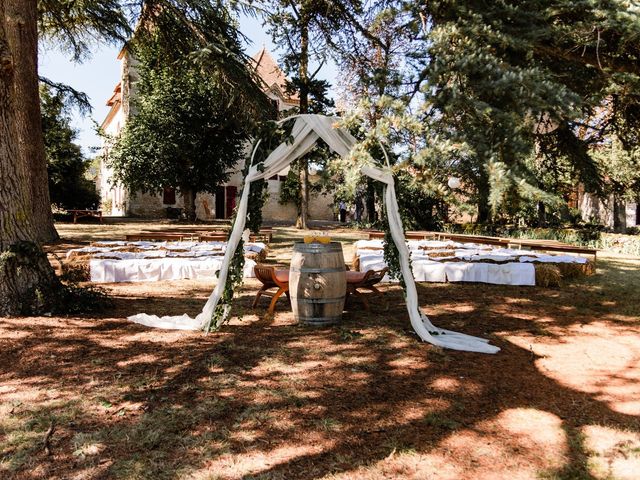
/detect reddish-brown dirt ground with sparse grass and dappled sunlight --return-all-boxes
[0,224,640,480]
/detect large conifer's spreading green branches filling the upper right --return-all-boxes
[334,0,640,227]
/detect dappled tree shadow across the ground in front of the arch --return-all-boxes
[0,253,640,479]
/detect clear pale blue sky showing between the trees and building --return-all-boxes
[39,17,336,157]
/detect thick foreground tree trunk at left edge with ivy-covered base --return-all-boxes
[0,0,63,316]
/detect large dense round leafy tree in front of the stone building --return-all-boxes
[108,27,251,218]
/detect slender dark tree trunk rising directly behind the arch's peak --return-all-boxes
[296,9,309,229]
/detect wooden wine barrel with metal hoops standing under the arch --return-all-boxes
[289,242,347,326]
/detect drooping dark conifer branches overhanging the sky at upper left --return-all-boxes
[38,0,270,117]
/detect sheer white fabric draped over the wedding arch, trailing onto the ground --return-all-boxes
[129,115,500,353]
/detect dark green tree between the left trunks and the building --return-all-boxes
[40,85,100,209]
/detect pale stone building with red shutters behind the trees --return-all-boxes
[98,47,334,222]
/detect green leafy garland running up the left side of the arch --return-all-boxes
[206,119,295,332]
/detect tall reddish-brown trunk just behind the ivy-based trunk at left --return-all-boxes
[2,0,58,242]
